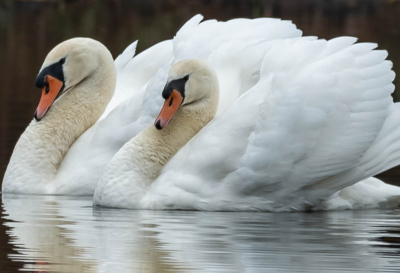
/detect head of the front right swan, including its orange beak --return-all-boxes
[154,59,218,130]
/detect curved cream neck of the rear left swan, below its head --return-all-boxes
[3,59,116,194]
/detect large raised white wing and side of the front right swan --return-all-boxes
[149,37,394,211]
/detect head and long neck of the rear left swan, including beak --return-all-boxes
[2,38,116,194]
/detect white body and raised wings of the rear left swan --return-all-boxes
[54,15,301,194]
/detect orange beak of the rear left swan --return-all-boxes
[35,75,64,121]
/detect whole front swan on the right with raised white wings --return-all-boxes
[93,37,400,211]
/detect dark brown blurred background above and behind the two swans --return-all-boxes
[0,0,400,185]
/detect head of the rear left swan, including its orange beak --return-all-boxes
[34,38,113,121]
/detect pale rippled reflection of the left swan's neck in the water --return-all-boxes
[1,196,94,272]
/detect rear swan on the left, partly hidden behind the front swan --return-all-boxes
[2,15,301,193]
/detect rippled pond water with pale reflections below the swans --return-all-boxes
[0,192,400,272]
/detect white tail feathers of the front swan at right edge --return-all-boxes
[314,103,400,210]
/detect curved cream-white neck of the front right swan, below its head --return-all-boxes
[94,82,219,208]
